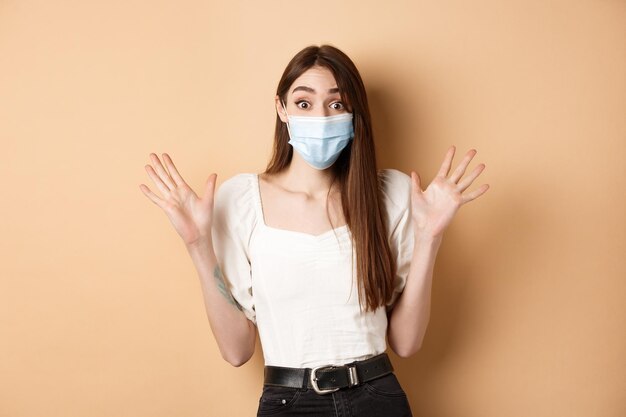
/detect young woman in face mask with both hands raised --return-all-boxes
[140,45,488,417]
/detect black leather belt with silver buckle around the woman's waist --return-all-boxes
[264,353,394,394]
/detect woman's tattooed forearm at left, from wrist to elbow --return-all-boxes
[187,241,256,366]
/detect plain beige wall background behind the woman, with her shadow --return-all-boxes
[0,0,626,417]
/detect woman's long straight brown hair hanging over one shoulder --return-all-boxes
[265,45,396,311]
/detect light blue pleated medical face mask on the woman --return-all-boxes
[282,102,354,169]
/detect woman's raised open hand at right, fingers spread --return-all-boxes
[411,146,489,238]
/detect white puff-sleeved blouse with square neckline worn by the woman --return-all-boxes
[212,169,413,368]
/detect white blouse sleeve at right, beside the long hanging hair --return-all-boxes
[378,169,414,311]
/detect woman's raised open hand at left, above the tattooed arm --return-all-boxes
[139,153,217,246]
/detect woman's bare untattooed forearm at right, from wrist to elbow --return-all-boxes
[387,234,441,357]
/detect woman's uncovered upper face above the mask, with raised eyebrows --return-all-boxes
[276,66,348,123]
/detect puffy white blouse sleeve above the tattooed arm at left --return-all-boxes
[211,174,256,324]
